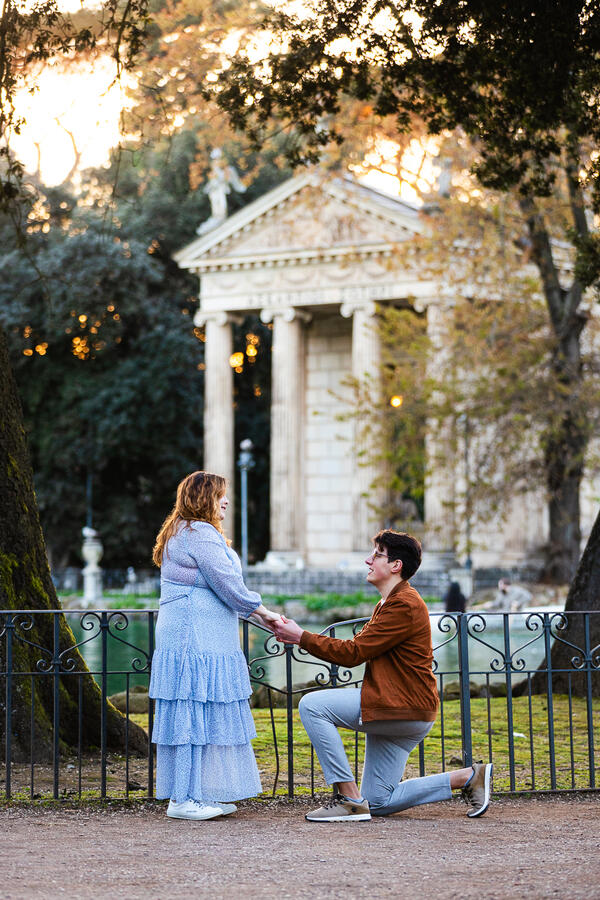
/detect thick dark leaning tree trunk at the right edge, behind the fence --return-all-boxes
[513,513,600,697]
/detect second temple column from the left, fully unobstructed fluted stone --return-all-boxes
[261,308,310,565]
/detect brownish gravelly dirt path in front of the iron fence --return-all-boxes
[0,794,600,900]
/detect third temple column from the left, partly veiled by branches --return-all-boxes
[340,303,383,563]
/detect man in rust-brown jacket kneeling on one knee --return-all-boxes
[274,530,492,822]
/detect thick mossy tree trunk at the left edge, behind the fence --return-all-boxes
[0,329,148,761]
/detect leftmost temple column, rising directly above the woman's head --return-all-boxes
[194,311,235,520]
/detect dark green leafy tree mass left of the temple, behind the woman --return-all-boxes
[0,211,202,566]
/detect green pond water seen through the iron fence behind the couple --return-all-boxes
[68,610,555,695]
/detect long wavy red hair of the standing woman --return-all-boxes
[152,472,227,566]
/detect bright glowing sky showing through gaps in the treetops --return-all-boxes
[11,0,440,202]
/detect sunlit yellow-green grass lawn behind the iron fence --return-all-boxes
[131,695,600,793]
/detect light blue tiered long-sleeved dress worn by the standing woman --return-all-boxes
[150,521,262,803]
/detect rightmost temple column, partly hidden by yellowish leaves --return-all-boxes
[422,302,457,570]
